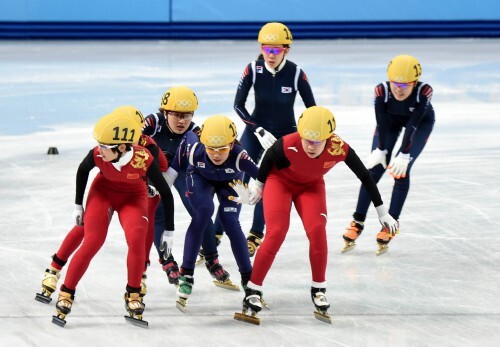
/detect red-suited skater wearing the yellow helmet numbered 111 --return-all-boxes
[49,111,174,326]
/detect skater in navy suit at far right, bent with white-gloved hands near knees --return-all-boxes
[343,55,435,255]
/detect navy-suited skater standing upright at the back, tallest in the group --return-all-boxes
[234,22,316,256]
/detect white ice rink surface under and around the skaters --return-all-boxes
[0,39,500,347]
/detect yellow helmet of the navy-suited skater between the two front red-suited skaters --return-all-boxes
[200,115,238,147]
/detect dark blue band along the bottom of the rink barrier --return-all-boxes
[0,20,500,40]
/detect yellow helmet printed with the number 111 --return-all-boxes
[94,110,142,145]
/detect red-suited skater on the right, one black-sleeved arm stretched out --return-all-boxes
[235,106,397,324]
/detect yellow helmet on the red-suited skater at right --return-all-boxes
[297,106,336,141]
